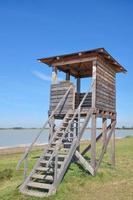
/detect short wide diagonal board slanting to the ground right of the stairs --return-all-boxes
[75,151,95,176]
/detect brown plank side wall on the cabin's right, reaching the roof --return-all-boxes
[96,63,116,112]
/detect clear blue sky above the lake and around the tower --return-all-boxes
[0,0,133,127]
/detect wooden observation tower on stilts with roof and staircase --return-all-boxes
[17,48,126,197]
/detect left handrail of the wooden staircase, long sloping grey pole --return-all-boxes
[16,85,73,170]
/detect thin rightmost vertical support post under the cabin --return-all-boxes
[111,120,115,166]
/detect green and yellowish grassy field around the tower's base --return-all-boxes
[0,137,133,200]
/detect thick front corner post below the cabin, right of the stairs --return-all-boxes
[91,114,96,169]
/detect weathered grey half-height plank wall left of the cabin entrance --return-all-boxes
[49,81,75,115]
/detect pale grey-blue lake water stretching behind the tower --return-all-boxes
[0,129,133,147]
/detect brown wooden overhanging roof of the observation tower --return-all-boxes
[38,48,127,78]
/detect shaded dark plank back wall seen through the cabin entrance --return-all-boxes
[75,92,92,108]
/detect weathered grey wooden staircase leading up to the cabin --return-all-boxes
[20,109,91,197]
